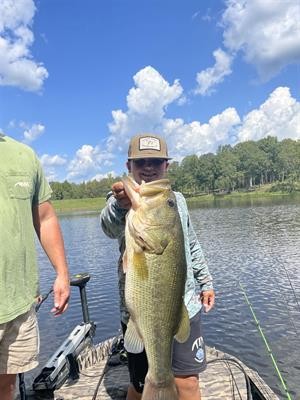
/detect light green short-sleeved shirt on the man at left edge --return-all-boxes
[0,134,51,323]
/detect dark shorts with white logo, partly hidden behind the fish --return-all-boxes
[122,312,206,393]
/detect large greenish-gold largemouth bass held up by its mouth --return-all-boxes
[123,177,190,400]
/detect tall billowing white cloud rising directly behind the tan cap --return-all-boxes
[108,67,240,163]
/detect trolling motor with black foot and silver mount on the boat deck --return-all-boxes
[32,273,96,391]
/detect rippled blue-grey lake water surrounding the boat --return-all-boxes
[31,201,300,400]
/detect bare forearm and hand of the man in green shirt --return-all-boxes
[32,201,70,315]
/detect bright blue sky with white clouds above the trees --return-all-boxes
[0,0,300,182]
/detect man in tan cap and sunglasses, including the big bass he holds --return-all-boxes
[100,133,215,400]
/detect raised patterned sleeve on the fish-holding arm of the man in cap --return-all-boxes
[100,192,128,239]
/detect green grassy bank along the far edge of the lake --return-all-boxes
[52,191,300,214]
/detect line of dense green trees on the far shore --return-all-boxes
[50,136,300,199]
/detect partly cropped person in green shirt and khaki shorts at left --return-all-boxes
[0,134,70,400]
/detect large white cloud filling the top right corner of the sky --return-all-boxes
[222,0,300,80]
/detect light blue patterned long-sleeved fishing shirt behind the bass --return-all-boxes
[100,192,213,324]
